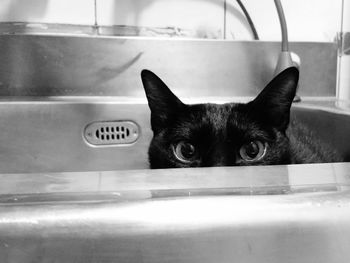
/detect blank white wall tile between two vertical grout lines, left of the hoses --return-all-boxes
[97,0,224,38]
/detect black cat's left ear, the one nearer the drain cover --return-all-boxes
[141,69,185,132]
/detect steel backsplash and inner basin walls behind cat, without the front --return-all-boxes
[0,32,344,173]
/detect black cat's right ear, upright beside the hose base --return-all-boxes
[248,67,299,131]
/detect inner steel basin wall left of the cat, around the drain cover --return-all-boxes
[0,98,152,173]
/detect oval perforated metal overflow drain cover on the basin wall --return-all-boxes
[84,121,139,145]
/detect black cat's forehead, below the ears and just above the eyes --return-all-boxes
[169,103,267,143]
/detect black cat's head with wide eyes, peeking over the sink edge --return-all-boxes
[141,67,299,168]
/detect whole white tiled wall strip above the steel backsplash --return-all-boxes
[0,0,344,41]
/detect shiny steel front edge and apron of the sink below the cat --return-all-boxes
[0,164,350,263]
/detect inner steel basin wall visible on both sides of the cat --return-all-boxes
[0,97,350,173]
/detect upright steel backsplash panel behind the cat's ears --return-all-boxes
[0,35,337,97]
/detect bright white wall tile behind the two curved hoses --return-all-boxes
[226,0,348,42]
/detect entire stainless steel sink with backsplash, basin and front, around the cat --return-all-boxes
[0,34,350,263]
